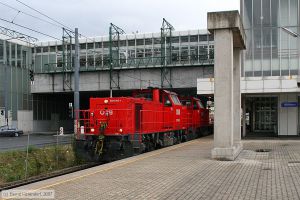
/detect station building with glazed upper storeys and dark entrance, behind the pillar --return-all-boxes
[197,0,300,136]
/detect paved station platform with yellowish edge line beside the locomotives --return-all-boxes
[8,136,300,200]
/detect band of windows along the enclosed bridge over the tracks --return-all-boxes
[33,30,214,73]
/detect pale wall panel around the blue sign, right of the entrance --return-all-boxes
[278,93,299,136]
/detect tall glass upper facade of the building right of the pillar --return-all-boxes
[241,0,300,77]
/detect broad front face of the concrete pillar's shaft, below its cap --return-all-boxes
[213,29,233,149]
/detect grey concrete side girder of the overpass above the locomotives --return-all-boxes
[31,62,213,94]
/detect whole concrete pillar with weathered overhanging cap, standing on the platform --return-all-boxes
[207,11,246,160]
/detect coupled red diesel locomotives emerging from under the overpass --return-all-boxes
[77,89,212,160]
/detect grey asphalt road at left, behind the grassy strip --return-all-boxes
[0,134,72,151]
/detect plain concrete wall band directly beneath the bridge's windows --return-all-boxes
[31,66,213,93]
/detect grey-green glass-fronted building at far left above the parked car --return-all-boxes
[0,39,32,121]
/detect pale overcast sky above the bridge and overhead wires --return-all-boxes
[0,0,240,40]
